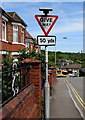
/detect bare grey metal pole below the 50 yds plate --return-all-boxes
[45,46,50,118]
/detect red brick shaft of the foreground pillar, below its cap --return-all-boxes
[30,63,42,106]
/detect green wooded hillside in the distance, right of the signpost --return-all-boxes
[48,51,85,67]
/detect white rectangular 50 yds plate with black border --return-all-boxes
[37,36,56,46]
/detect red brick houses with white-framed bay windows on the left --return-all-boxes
[0,8,40,56]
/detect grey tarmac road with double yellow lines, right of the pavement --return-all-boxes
[66,77,85,118]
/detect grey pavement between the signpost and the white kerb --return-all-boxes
[51,78,82,118]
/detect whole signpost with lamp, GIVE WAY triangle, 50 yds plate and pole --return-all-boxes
[35,8,58,119]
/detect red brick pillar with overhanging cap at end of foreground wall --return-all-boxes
[20,58,42,116]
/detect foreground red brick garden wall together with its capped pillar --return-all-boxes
[0,59,42,120]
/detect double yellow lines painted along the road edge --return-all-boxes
[66,80,85,109]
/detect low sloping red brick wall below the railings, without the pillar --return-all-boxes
[0,85,40,120]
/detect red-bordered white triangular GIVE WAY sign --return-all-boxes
[35,15,58,35]
